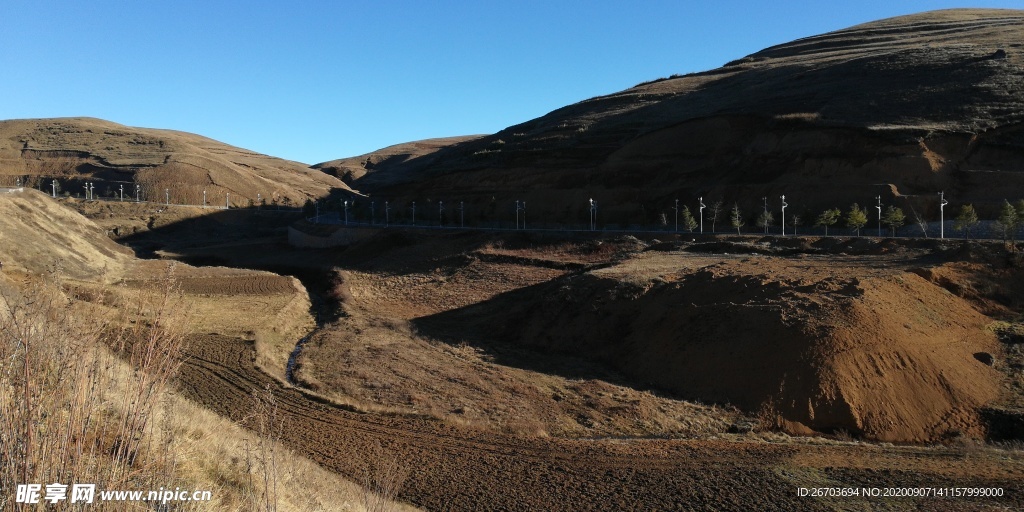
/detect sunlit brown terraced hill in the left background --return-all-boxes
[0,118,347,206]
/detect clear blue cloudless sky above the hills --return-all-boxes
[0,0,1024,164]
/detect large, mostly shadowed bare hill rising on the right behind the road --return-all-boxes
[325,9,1024,224]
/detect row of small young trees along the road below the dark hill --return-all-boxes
[678,200,1024,241]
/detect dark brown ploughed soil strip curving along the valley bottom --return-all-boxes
[180,335,1024,510]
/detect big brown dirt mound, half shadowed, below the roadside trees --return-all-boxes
[421,252,998,441]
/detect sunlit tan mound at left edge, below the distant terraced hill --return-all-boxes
[0,188,131,280]
